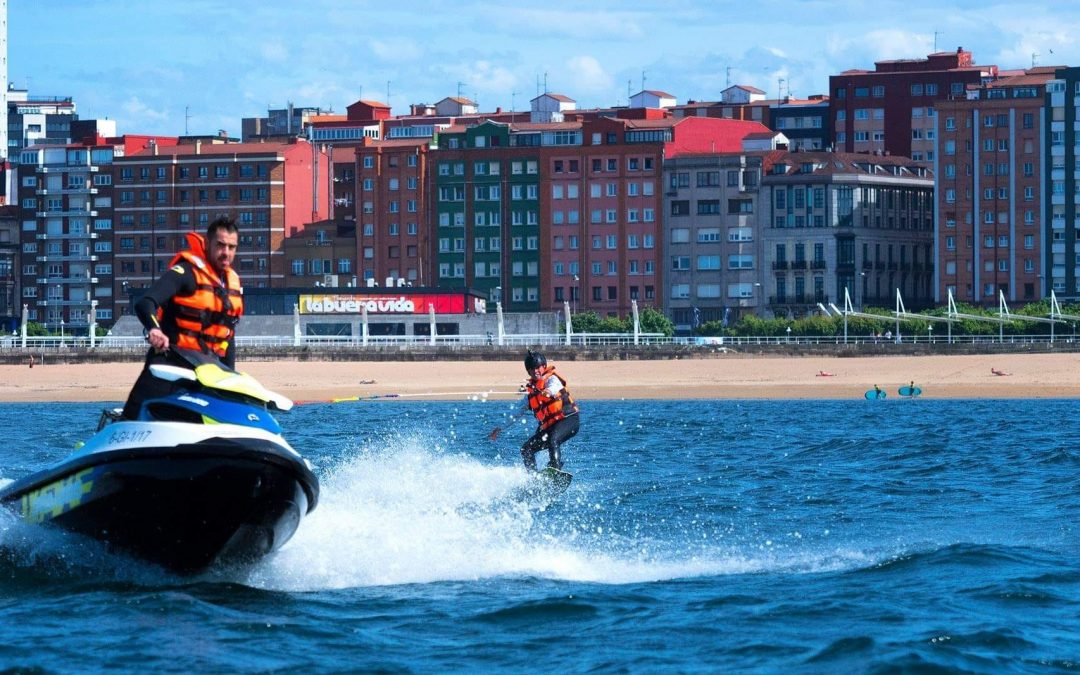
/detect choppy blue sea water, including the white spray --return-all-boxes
[0,399,1080,673]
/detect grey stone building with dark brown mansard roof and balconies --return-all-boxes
[759,152,934,318]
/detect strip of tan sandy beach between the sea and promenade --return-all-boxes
[0,353,1080,402]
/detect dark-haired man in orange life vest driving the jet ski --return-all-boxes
[123,216,244,419]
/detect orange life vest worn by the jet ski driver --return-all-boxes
[158,232,244,356]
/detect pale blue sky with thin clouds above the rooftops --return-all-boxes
[6,0,1080,136]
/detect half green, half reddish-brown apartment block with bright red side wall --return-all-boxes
[432,117,767,315]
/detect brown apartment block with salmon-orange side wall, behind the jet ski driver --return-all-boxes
[112,138,332,313]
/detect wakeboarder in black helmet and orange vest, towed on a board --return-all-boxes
[488,350,581,471]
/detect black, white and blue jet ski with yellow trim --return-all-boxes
[0,350,319,575]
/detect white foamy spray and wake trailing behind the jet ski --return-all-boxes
[238,437,888,591]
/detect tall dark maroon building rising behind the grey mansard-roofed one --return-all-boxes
[828,49,998,165]
